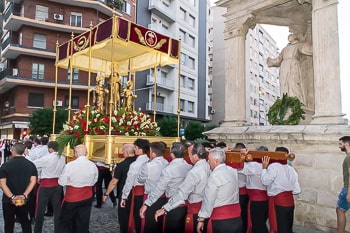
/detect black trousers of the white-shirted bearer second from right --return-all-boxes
[250,201,269,233]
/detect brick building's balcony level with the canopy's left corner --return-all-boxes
[1,36,56,59]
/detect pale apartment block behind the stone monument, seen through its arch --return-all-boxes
[211,6,280,125]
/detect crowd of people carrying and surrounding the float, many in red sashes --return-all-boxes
[0,137,350,233]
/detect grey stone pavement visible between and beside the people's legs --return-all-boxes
[0,195,325,233]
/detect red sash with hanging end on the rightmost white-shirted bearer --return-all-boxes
[269,191,294,233]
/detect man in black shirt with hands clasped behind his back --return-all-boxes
[0,143,38,233]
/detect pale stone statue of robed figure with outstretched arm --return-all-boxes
[266,34,312,105]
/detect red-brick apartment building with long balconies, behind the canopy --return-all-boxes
[0,0,136,139]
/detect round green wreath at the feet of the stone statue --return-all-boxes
[267,93,305,125]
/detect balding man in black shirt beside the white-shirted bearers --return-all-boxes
[102,143,136,233]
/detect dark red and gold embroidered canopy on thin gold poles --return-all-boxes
[56,16,180,75]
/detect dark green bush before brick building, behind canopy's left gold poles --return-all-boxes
[29,108,68,136]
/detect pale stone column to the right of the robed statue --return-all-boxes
[311,0,346,125]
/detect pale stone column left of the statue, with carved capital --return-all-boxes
[222,15,255,126]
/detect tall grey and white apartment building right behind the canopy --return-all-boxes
[135,0,211,127]
